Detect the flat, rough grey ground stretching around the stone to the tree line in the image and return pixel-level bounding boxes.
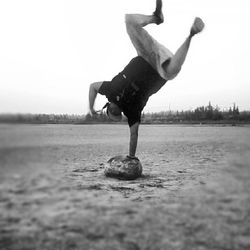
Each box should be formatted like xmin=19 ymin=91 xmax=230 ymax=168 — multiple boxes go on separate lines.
xmin=0 ymin=125 xmax=250 ymax=250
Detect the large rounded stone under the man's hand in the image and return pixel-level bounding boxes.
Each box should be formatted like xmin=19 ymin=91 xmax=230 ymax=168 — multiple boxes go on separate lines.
xmin=104 ymin=155 xmax=142 ymax=180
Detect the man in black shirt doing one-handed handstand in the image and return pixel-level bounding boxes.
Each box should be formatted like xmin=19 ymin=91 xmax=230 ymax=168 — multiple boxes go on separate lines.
xmin=89 ymin=0 xmax=204 ymax=158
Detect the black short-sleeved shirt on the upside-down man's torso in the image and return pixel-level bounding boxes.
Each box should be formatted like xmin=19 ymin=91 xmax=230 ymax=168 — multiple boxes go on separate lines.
xmin=99 ymin=56 xmax=166 ymax=126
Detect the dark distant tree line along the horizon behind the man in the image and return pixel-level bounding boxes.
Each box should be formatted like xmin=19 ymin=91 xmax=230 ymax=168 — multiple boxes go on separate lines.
xmin=0 ymin=102 xmax=250 ymax=124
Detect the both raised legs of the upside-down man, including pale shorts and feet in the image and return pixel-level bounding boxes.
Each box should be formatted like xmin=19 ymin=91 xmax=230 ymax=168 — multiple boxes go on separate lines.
xmin=126 ymin=0 xmax=204 ymax=80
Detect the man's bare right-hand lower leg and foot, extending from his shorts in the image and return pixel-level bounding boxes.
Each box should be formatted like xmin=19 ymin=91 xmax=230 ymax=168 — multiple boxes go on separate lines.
xmin=162 ymin=17 xmax=204 ymax=79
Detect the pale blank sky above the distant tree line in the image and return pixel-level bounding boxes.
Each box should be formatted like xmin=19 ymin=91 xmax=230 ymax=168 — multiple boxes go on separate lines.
xmin=0 ymin=0 xmax=250 ymax=115
